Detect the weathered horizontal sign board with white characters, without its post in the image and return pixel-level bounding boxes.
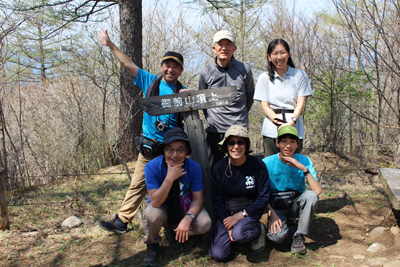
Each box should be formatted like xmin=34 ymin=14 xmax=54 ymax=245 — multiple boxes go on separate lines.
xmin=139 ymin=86 xmax=237 ymax=116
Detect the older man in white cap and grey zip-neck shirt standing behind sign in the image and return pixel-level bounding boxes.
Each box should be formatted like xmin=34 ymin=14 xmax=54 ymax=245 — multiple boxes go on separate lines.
xmin=199 ymin=30 xmax=254 ymax=168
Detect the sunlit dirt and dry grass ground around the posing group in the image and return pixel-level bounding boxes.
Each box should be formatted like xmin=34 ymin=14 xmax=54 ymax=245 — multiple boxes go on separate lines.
xmin=0 ymin=153 xmax=400 ymax=267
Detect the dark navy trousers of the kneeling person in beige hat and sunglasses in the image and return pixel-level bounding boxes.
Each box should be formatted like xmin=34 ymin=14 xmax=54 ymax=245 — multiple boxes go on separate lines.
xmin=208 ymin=216 xmax=261 ymax=261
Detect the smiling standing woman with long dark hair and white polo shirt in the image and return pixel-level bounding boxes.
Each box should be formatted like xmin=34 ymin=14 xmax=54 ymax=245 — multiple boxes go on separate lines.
xmin=254 ymin=39 xmax=313 ymax=157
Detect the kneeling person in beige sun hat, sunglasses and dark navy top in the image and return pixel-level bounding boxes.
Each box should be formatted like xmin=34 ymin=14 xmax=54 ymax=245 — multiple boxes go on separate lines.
xmin=209 ymin=125 xmax=269 ymax=261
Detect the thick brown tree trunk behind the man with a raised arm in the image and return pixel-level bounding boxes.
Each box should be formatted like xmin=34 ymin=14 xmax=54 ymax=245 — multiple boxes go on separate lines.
xmin=118 ymin=0 xmax=143 ymax=162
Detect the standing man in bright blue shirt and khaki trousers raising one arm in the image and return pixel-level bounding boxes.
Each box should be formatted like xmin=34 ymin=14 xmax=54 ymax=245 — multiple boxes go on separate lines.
xmin=98 ymin=29 xmax=185 ymax=234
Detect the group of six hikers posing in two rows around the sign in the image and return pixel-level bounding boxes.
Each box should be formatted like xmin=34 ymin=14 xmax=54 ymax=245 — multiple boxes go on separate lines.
xmin=98 ymin=30 xmax=322 ymax=266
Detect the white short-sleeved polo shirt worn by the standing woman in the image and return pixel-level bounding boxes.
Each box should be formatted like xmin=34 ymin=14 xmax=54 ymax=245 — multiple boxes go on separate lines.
xmin=254 ymin=67 xmax=313 ymax=139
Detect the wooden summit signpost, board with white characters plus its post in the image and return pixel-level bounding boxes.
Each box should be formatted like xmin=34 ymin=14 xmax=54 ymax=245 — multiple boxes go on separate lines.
xmin=139 ymin=86 xmax=237 ymax=222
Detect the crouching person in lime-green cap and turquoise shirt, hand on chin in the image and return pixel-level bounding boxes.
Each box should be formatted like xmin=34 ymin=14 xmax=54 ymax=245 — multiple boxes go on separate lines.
xmin=263 ymin=125 xmax=322 ymax=254
